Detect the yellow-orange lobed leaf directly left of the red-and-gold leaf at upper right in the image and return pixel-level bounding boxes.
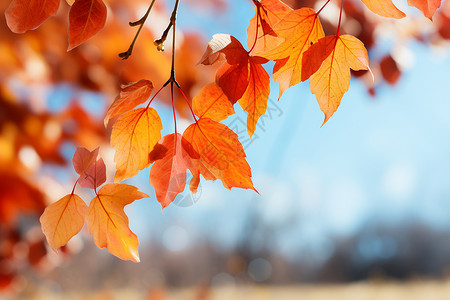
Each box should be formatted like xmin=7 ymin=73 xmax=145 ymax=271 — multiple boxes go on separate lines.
xmin=259 ymin=8 xmax=324 ymax=97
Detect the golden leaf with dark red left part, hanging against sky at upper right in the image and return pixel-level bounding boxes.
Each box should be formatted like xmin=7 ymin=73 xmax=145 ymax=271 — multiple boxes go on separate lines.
xmin=302 ymin=35 xmax=370 ymax=126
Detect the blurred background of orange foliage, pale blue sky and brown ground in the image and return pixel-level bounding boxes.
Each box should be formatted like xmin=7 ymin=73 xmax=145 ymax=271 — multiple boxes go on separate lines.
xmin=0 ymin=0 xmax=450 ymax=299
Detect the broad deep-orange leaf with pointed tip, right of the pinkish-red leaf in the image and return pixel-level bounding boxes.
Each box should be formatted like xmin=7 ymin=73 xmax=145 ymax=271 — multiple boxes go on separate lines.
xmin=183 ymin=118 xmax=256 ymax=191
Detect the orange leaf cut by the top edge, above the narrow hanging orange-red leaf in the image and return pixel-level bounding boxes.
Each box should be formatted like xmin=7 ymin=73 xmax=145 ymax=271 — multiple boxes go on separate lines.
xmin=247 ymin=0 xmax=292 ymax=55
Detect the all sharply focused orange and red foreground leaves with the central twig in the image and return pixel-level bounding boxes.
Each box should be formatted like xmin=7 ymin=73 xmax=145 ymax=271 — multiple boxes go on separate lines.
xmin=5 ymin=0 xmax=446 ymax=261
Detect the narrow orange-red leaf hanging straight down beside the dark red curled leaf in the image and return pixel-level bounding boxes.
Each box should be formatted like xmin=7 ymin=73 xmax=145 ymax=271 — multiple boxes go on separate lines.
xmin=239 ymin=57 xmax=270 ymax=137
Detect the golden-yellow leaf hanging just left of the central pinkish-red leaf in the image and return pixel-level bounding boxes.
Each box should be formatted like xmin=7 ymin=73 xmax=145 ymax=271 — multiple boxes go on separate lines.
xmin=111 ymin=108 xmax=162 ymax=182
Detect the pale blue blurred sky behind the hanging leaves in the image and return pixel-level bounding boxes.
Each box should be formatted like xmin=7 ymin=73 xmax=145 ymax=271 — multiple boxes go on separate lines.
xmin=118 ymin=2 xmax=450 ymax=258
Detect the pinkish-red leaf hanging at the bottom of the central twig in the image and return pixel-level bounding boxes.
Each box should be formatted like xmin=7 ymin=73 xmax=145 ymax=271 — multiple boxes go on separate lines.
xmin=149 ymin=133 xmax=199 ymax=208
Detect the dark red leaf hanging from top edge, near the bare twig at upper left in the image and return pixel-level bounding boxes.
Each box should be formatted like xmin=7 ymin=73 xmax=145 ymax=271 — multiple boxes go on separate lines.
xmin=68 ymin=0 xmax=107 ymax=51
